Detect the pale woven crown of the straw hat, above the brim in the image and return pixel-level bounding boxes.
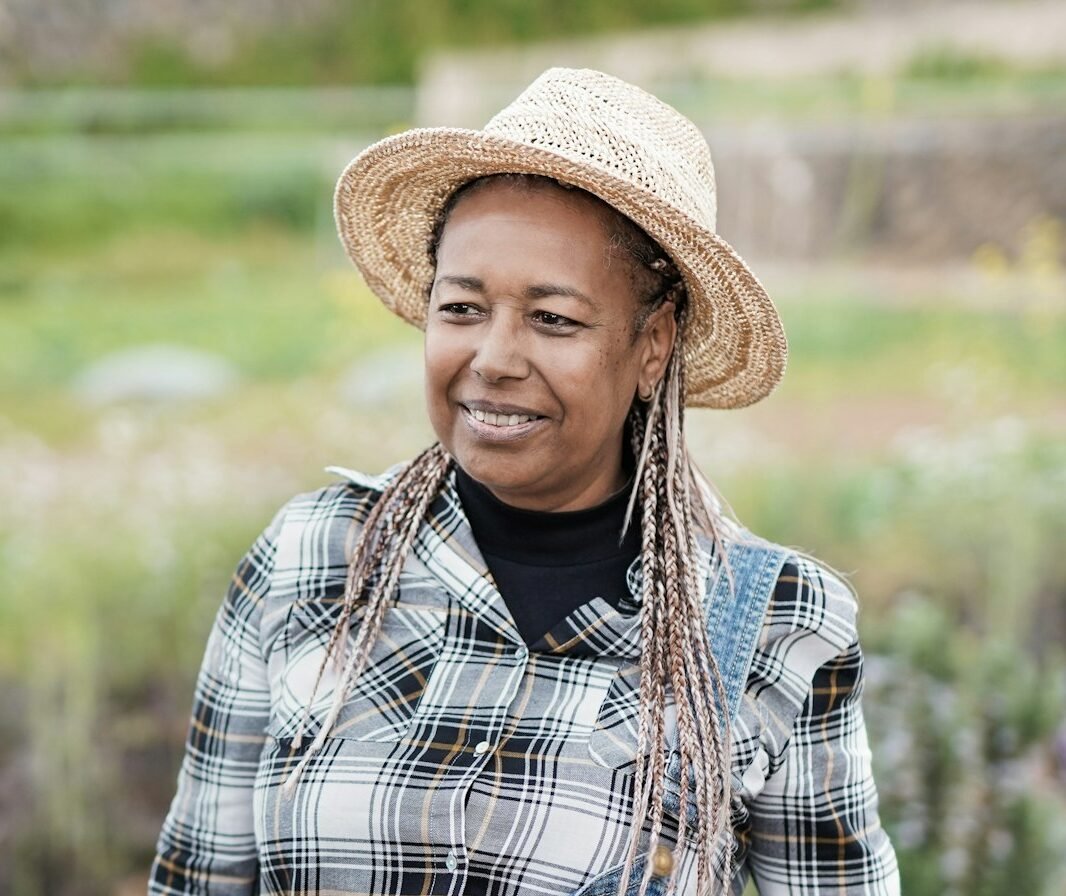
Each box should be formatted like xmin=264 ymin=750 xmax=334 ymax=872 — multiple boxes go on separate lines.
xmin=484 ymin=68 xmax=717 ymax=231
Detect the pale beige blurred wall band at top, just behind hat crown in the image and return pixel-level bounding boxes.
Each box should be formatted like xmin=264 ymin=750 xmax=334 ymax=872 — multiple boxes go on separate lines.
xmin=417 ymin=0 xmax=1066 ymax=127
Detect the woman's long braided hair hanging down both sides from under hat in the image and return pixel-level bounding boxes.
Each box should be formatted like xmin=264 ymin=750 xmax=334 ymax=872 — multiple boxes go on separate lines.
xmin=284 ymin=174 xmax=732 ymax=896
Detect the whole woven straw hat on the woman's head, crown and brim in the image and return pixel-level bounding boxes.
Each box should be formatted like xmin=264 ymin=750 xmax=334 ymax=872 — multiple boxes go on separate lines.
xmin=334 ymin=68 xmax=788 ymax=408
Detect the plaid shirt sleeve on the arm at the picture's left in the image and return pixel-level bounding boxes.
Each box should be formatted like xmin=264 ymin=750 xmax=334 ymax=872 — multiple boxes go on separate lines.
xmin=148 ymin=511 xmax=284 ymax=896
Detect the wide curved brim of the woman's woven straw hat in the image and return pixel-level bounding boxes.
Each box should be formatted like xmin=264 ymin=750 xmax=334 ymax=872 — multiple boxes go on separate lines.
xmin=334 ymin=128 xmax=788 ymax=408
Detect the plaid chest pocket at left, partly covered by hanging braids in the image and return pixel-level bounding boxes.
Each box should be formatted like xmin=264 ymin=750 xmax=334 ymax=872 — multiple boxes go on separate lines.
xmin=269 ymin=580 xmax=448 ymax=743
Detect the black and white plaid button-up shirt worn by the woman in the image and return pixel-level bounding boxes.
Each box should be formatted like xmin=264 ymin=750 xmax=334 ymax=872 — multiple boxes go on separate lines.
xmin=149 ymin=473 xmax=899 ymax=896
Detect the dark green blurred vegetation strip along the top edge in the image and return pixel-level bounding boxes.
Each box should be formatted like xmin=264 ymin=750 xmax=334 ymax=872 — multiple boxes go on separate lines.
xmin=10 ymin=0 xmax=838 ymax=86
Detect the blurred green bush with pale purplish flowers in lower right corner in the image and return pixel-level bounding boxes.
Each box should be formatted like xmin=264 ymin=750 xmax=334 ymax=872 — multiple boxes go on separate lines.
xmin=865 ymin=593 xmax=1066 ymax=896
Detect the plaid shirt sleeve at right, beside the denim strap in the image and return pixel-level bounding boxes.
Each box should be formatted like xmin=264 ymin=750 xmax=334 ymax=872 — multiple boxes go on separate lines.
xmin=747 ymin=567 xmax=900 ymax=896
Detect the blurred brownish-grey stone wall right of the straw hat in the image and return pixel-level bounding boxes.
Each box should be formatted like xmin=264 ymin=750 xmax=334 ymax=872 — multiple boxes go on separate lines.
xmin=708 ymin=114 xmax=1066 ymax=265
